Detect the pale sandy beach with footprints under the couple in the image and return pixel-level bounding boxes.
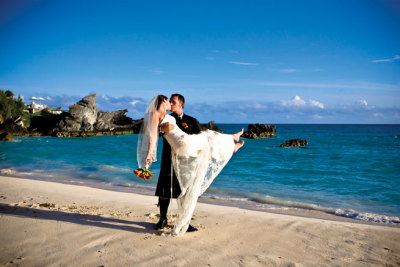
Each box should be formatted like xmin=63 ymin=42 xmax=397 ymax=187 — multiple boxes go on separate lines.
xmin=0 ymin=176 xmax=400 ymax=266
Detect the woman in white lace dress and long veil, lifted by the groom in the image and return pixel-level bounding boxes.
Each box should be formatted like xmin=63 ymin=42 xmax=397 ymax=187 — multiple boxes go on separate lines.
xmin=137 ymin=95 xmax=244 ymax=235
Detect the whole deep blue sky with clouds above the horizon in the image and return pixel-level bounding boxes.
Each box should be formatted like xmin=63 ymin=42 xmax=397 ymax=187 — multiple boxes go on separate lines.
xmin=0 ymin=0 xmax=400 ymax=123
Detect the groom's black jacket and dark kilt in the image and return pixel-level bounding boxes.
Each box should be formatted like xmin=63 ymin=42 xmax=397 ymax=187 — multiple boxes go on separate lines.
xmin=155 ymin=113 xmax=200 ymax=198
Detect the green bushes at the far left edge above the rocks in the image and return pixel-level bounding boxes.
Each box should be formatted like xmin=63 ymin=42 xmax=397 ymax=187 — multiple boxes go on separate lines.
xmin=0 ymin=89 xmax=25 ymax=120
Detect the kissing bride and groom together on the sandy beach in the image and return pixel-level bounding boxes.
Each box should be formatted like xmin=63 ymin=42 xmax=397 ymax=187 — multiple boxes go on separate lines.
xmin=137 ymin=94 xmax=244 ymax=236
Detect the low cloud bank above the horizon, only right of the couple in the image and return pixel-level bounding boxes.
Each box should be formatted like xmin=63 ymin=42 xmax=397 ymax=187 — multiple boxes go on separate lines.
xmin=180 ymin=100 xmax=400 ymax=123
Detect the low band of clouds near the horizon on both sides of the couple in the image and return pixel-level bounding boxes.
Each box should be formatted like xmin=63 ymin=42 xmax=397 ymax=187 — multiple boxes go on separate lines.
xmin=31 ymin=95 xmax=400 ymax=123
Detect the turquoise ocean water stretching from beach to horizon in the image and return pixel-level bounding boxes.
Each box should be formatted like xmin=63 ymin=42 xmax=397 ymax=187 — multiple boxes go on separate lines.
xmin=0 ymin=124 xmax=400 ymax=224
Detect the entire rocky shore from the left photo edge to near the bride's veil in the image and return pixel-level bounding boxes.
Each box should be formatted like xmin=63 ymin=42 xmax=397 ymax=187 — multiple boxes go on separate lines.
xmin=0 ymin=93 xmax=142 ymax=140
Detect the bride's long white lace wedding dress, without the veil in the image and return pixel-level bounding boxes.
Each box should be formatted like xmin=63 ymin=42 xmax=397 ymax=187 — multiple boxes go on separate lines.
xmin=161 ymin=114 xmax=235 ymax=235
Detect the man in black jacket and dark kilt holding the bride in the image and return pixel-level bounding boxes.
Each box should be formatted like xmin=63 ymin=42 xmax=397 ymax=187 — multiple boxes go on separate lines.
xmin=155 ymin=94 xmax=200 ymax=232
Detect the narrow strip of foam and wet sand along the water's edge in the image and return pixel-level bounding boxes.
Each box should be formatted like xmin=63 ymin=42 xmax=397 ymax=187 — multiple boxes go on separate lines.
xmin=0 ymin=172 xmax=400 ymax=227
